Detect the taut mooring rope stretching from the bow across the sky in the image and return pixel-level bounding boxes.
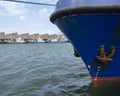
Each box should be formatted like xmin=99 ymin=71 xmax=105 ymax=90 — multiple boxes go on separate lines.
xmin=1 ymin=0 xmax=56 ymax=6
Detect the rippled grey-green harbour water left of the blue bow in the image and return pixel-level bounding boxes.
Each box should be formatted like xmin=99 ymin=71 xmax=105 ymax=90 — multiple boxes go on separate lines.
xmin=0 ymin=43 xmax=90 ymax=96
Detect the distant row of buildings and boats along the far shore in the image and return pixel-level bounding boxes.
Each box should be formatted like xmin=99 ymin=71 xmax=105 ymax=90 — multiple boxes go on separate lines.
xmin=0 ymin=32 xmax=68 ymax=44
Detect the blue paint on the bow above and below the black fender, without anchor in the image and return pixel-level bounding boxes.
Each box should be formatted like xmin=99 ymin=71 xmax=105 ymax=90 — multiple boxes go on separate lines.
xmin=51 ymin=0 xmax=120 ymax=77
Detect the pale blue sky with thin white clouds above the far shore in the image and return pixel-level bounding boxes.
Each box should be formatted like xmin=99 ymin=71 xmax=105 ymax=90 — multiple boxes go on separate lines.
xmin=0 ymin=0 xmax=60 ymax=34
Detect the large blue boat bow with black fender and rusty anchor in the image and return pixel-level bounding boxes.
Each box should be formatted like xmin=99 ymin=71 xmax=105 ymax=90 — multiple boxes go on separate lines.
xmin=50 ymin=0 xmax=120 ymax=82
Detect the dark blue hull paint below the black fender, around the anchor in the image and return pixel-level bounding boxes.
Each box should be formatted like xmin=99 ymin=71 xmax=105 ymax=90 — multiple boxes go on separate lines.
xmin=55 ymin=15 xmax=120 ymax=77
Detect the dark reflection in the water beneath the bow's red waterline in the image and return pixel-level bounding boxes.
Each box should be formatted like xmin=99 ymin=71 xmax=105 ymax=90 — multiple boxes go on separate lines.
xmin=75 ymin=82 xmax=120 ymax=96
